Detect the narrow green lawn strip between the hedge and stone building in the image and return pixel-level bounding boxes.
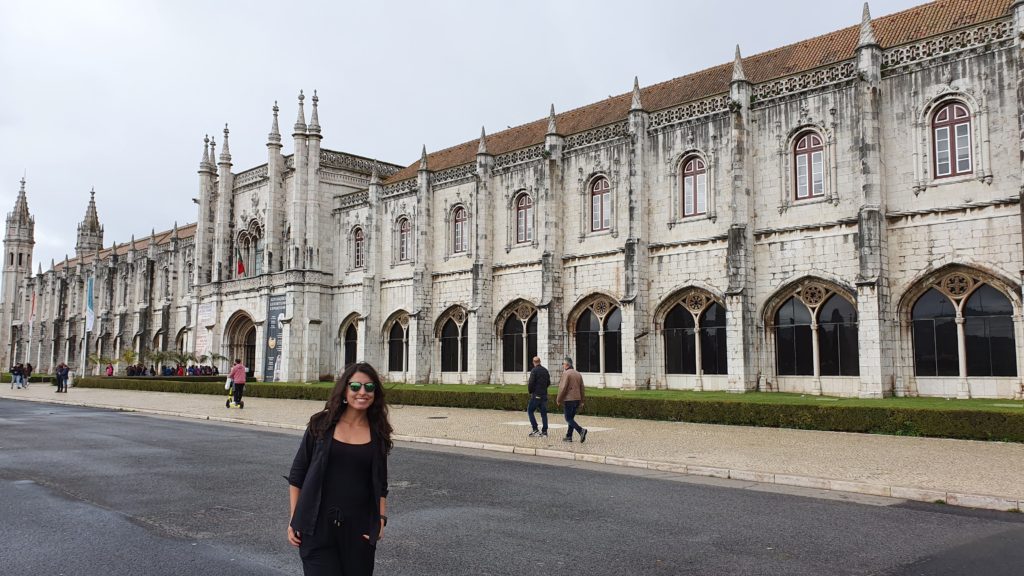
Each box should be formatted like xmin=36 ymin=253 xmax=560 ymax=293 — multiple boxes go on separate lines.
xmin=272 ymin=382 xmax=1024 ymax=413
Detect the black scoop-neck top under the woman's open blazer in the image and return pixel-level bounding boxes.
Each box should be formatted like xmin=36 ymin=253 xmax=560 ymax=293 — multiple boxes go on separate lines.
xmin=321 ymin=439 xmax=375 ymax=530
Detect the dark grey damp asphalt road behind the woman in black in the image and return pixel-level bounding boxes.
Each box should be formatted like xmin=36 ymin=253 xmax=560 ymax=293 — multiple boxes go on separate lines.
xmin=0 ymin=400 xmax=1024 ymax=576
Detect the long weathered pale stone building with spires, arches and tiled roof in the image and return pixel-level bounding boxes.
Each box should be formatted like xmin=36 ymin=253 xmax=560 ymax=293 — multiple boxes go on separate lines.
xmin=0 ymin=0 xmax=1024 ymax=398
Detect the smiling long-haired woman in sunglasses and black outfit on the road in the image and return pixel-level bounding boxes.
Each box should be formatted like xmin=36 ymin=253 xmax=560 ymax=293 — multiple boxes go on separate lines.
xmin=288 ymin=362 xmax=392 ymax=576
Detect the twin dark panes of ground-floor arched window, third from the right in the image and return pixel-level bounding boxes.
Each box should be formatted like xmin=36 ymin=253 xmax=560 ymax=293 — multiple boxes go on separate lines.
xmin=664 ymin=301 xmax=728 ymax=374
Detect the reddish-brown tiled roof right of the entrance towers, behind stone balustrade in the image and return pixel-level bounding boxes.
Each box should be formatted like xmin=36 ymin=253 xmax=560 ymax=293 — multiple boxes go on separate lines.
xmin=387 ymin=0 xmax=1013 ymax=182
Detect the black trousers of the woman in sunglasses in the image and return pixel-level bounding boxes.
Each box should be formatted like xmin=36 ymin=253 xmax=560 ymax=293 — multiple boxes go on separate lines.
xmin=299 ymin=513 xmax=377 ymax=576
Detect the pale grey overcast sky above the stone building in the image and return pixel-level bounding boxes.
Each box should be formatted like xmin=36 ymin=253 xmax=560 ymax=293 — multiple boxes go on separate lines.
xmin=0 ymin=0 xmax=922 ymax=270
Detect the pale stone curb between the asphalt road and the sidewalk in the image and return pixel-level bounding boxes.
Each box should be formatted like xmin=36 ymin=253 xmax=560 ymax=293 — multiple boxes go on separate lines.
xmin=0 ymin=397 xmax=1024 ymax=512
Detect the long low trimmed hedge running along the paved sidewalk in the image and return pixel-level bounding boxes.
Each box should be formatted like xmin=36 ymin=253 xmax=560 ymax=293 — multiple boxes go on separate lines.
xmin=76 ymin=378 xmax=1024 ymax=442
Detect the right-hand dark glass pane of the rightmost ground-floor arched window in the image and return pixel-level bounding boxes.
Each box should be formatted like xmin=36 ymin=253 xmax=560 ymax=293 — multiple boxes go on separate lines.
xmin=964 ymin=284 xmax=1017 ymax=376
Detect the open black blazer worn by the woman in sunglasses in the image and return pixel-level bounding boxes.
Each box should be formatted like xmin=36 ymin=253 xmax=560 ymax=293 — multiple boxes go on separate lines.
xmin=288 ymin=426 xmax=387 ymax=544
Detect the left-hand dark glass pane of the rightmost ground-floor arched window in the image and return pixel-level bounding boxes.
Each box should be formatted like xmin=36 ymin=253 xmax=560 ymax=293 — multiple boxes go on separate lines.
xmin=910 ymin=288 xmax=959 ymax=376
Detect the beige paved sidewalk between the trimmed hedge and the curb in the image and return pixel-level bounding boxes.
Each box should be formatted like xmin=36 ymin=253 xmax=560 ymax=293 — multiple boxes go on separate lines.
xmin=0 ymin=384 xmax=1024 ymax=510
